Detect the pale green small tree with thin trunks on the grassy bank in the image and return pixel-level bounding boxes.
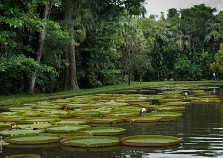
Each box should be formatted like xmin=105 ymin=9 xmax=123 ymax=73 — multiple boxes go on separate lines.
xmin=120 ymin=18 xmax=150 ymax=85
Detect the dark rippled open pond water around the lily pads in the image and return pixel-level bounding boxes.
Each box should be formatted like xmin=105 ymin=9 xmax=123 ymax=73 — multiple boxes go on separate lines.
xmin=0 ymin=84 xmax=223 ymax=158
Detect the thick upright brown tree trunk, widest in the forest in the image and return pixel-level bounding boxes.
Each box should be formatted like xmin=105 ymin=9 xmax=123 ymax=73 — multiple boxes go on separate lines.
xmin=64 ymin=8 xmax=79 ymax=90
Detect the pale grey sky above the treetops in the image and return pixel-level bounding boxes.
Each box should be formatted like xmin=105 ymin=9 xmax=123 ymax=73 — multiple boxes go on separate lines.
xmin=145 ymin=0 xmax=223 ymax=16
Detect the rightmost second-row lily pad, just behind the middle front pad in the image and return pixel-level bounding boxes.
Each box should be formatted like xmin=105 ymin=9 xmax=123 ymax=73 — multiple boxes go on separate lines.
xmin=78 ymin=127 xmax=125 ymax=136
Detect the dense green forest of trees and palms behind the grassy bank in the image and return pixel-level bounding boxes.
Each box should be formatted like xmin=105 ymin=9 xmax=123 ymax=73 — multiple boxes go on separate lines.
xmin=0 ymin=0 xmax=223 ymax=94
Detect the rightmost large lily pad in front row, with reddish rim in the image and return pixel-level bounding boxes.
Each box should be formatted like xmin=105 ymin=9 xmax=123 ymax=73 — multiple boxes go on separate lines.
xmin=122 ymin=135 xmax=180 ymax=146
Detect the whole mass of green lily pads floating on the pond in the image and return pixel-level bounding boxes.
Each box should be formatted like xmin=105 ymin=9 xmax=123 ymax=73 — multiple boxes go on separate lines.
xmin=0 ymin=85 xmax=220 ymax=157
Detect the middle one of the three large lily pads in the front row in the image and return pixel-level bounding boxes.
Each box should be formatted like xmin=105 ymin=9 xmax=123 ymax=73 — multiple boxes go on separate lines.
xmin=61 ymin=136 xmax=120 ymax=147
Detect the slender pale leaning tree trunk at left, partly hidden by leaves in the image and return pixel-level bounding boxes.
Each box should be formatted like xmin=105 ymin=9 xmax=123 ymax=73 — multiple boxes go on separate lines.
xmin=29 ymin=2 xmax=52 ymax=93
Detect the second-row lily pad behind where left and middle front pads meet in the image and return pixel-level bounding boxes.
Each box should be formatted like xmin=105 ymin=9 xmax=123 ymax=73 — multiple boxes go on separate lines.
xmin=46 ymin=125 xmax=90 ymax=133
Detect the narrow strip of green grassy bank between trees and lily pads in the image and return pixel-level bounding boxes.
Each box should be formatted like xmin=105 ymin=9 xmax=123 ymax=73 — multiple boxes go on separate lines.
xmin=0 ymin=81 xmax=223 ymax=106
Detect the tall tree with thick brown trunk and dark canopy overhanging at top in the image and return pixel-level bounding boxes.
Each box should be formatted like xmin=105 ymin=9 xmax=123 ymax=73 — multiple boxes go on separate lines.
xmin=59 ymin=0 xmax=145 ymax=89
